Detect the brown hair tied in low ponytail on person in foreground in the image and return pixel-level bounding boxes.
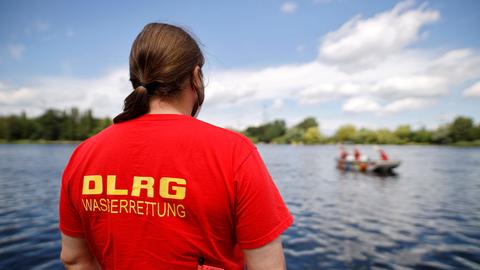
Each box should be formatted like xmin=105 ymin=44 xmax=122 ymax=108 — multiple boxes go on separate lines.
xmin=113 ymin=23 xmax=205 ymax=124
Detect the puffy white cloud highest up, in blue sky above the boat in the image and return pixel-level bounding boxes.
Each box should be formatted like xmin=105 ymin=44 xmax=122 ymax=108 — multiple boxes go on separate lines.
xmin=320 ymin=1 xmax=440 ymax=66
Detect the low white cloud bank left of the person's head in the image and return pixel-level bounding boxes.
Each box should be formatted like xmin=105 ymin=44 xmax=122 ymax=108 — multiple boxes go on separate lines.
xmin=0 ymin=68 xmax=132 ymax=116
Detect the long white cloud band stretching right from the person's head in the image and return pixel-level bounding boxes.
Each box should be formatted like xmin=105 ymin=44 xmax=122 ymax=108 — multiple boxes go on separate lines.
xmin=208 ymin=45 xmax=474 ymax=106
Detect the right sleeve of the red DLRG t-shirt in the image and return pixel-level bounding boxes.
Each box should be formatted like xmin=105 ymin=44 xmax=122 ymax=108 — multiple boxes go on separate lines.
xmin=234 ymin=148 xmax=293 ymax=249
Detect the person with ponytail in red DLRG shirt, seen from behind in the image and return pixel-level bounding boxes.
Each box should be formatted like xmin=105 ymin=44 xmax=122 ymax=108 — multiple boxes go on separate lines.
xmin=59 ymin=23 xmax=293 ymax=270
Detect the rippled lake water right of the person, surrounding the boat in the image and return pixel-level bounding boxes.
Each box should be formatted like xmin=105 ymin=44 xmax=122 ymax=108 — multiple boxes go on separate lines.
xmin=259 ymin=146 xmax=480 ymax=269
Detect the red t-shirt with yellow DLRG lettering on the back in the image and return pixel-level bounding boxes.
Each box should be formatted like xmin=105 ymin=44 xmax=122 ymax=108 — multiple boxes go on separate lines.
xmin=59 ymin=114 xmax=293 ymax=269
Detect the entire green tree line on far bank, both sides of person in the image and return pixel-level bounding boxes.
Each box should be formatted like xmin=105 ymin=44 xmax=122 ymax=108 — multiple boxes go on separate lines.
xmin=0 ymin=107 xmax=480 ymax=146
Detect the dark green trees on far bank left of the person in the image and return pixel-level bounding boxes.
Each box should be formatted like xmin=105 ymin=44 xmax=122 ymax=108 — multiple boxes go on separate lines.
xmin=0 ymin=107 xmax=112 ymax=142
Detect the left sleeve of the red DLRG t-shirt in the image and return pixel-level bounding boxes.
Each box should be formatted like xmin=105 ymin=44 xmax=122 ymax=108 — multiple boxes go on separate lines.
xmin=59 ymin=149 xmax=84 ymax=238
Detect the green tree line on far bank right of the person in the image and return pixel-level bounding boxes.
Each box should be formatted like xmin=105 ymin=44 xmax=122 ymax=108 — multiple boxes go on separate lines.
xmin=241 ymin=116 xmax=480 ymax=146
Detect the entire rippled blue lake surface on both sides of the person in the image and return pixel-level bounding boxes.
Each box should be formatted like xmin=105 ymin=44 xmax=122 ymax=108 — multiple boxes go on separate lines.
xmin=0 ymin=145 xmax=480 ymax=269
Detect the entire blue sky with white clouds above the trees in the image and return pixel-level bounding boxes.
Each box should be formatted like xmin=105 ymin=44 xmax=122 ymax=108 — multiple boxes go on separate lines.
xmin=0 ymin=0 xmax=480 ymax=133
